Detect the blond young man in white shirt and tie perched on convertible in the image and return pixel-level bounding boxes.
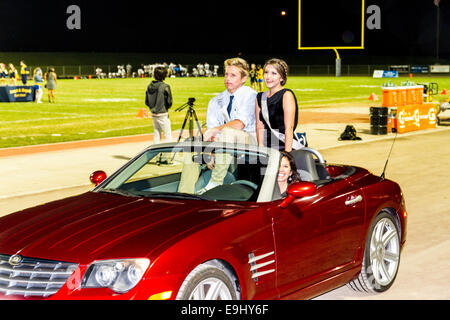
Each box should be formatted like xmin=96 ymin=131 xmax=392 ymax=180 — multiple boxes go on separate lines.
xmin=179 ymin=58 xmax=256 ymax=194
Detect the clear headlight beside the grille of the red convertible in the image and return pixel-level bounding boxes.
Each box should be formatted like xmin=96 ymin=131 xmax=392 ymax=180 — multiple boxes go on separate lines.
xmin=81 ymin=259 xmax=150 ymax=293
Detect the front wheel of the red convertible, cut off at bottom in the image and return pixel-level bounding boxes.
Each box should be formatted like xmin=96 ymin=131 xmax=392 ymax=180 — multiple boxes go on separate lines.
xmin=176 ymin=260 xmax=240 ymax=300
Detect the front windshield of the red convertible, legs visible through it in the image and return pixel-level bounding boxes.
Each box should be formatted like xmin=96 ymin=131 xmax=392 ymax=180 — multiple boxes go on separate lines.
xmin=96 ymin=147 xmax=268 ymax=201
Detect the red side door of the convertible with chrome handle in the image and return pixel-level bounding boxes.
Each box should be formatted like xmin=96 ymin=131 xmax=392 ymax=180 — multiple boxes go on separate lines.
xmin=271 ymin=180 xmax=364 ymax=296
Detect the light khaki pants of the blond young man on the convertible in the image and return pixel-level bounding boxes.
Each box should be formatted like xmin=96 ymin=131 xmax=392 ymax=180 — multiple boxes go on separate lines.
xmin=178 ymin=127 xmax=253 ymax=193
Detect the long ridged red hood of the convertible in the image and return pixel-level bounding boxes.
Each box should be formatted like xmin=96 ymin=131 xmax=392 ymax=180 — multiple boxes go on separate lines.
xmin=0 ymin=192 xmax=244 ymax=264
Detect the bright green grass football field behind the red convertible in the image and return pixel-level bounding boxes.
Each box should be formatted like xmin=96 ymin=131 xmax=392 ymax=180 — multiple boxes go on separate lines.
xmin=0 ymin=77 xmax=450 ymax=148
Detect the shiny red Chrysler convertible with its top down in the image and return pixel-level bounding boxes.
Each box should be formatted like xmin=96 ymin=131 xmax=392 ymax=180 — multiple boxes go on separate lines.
xmin=0 ymin=142 xmax=406 ymax=300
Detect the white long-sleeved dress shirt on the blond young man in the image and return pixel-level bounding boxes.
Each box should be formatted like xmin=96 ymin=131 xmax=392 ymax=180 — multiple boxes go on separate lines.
xmin=206 ymin=86 xmax=256 ymax=133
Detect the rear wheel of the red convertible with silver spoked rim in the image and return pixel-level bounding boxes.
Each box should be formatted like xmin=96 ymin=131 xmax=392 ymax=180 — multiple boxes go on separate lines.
xmin=348 ymin=211 xmax=400 ymax=293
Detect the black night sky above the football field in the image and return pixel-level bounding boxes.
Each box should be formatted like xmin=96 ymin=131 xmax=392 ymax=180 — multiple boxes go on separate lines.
xmin=0 ymin=0 xmax=450 ymax=59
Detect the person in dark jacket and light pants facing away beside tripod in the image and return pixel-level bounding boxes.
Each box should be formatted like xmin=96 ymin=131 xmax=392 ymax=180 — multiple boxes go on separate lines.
xmin=145 ymin=67 xmax=172 ymax=143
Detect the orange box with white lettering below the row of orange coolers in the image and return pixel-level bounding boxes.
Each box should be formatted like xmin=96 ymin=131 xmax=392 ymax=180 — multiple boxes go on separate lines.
xmin=396 ymin=103 xmax=437 ymax=133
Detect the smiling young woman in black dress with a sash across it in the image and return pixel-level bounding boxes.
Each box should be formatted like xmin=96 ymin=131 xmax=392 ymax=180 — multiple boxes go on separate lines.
xmin=255 ymin=59 xmax=298 ymax=152
